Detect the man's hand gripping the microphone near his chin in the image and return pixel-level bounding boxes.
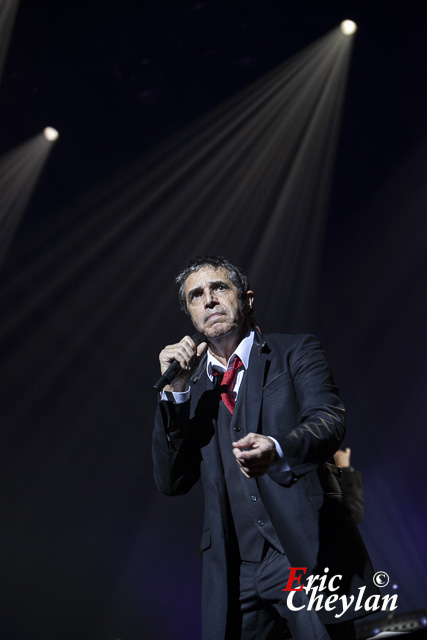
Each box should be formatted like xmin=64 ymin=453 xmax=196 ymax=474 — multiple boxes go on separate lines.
xmin=159 ymin=336 xmax=208 ymax=392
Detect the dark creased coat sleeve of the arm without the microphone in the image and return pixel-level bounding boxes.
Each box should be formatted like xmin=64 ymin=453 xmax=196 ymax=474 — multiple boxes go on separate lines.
xmin=279 ymin=335 xmax=345 ymax=477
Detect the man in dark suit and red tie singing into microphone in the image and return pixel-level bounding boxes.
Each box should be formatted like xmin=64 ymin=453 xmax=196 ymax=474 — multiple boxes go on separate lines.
xmin=153 ymin=256 xmax=376 ymax=640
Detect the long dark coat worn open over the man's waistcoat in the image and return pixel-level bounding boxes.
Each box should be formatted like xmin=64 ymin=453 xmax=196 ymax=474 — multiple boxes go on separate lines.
xmin=153 ymin=333 xmax=376 ymax=640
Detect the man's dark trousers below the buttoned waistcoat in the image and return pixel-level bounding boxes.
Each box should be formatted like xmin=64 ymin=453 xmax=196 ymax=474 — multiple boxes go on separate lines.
xmin=237 ymin=545 xmax=356 ymax=640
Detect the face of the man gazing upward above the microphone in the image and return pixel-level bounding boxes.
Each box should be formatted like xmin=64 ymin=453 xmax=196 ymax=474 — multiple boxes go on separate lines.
xmin=185 ymin=267 xmax=253 ymax=339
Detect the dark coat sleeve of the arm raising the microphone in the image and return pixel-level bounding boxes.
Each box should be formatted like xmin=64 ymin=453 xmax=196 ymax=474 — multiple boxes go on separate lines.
xmin=152 ymin=400 xmax=201 ymax=496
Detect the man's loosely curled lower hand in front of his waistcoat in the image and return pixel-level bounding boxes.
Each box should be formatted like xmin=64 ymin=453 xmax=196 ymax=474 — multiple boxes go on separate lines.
xmin=232 ymin=433 xmax=277 ymax=478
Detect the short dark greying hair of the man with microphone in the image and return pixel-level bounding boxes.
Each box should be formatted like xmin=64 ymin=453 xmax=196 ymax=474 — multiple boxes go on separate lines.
xmin=175 ymin=256 xmax=253 ymax=321
